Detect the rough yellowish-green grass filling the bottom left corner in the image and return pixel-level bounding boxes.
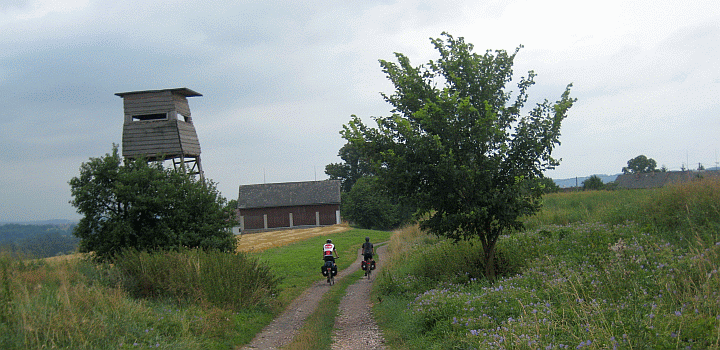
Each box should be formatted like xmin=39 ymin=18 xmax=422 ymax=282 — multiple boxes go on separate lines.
xmin=0 ymin=254 xmax=248 ymax=349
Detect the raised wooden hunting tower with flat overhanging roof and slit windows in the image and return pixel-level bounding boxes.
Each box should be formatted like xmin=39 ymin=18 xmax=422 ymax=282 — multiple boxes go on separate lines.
xmin=115 ymin=88 xmax=203 ymax=178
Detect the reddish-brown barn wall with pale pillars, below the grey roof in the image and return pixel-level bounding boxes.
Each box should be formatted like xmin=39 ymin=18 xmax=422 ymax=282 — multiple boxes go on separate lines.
xmin=238 ymin=204 xmax=340 ymax=230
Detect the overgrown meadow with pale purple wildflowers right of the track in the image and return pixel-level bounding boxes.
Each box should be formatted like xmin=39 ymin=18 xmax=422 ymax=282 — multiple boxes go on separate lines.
xmin=374 ymin=180 xmax=720 ymax=349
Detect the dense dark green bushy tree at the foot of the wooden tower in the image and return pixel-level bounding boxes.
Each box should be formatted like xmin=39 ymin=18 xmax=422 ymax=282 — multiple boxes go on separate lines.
xmin=69 ymin=146 xmax=237 ymax=259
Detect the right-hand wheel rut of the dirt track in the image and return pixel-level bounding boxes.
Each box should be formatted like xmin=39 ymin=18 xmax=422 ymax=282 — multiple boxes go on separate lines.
xmin=332 ymin=246 xmax=385 ymax=350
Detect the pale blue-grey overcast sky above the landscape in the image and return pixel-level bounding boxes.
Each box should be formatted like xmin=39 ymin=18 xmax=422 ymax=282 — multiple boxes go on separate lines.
xmin=0 ymin=0 xmax=720 ymax=221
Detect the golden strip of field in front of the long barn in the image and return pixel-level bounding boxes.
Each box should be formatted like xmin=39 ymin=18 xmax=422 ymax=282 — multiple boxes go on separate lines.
xmin=236 ymin=224 xmax=350 ymax=252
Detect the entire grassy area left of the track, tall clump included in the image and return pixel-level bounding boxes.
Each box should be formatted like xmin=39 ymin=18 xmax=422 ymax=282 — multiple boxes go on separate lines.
xmin=0 ymin=228 xmax=390 ymax=349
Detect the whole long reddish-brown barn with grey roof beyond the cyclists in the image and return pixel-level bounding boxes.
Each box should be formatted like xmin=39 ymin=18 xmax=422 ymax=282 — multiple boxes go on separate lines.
xmin=233 ymin=180 xmax=340 ymax=231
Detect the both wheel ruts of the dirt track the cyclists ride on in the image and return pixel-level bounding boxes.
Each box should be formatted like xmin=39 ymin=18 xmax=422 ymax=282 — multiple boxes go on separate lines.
xmin=241 ymin=243 xmax=384 ymax=350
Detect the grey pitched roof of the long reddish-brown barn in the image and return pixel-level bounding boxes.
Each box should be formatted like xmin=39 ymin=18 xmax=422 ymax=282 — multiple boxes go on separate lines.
xmin=238 ymin=180 xmax=340 ymax=209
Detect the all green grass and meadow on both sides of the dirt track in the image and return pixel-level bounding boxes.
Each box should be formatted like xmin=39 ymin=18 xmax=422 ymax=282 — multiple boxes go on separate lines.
xmin=5 ymin=180 xmax=720 ymax=349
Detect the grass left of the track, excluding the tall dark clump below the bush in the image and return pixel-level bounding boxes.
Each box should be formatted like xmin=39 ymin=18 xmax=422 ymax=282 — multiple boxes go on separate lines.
xmin=0 ymin=230 xmax=390 ymax=349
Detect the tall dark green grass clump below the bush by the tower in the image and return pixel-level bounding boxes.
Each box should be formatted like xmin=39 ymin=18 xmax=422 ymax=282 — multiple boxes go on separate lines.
xmin=108 ymin=249 xmax=279 ymax=310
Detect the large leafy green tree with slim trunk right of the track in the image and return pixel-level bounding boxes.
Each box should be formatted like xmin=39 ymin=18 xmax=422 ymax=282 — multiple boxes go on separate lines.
xmin=342 ymin=33 xmax=575 ymax=280
